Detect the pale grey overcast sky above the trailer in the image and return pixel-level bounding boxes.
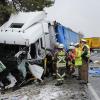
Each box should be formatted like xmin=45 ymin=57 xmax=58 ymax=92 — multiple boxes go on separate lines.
xmin=47 ymin=0 xmax=100 ymax=37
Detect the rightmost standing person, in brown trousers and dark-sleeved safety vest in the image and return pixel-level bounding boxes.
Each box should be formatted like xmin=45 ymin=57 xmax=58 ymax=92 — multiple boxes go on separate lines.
xmin=80 ymin=39 xmax=90 ymax=84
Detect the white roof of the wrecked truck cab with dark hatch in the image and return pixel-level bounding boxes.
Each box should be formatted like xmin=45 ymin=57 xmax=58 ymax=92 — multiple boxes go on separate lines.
xmin=0 ymin=11 xmax=48 ymax=45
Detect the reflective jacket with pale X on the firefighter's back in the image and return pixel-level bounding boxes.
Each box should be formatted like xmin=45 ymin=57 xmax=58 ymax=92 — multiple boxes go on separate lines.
xmin=57 ymin=50 xmax=66 ymax=67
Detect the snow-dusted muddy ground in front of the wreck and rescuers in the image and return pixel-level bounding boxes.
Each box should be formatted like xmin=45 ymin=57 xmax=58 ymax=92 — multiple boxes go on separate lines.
xmin=0 ymin=78 xmax=90 ymax=100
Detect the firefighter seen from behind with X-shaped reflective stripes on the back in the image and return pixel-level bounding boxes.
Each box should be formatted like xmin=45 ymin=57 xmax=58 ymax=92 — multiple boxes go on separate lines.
xmin=54 ymin=44 xmax=66 ymax=86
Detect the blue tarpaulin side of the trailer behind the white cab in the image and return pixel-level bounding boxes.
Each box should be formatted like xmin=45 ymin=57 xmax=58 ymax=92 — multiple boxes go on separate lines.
xmin=56 ymin=24 xmax=80 ymax=49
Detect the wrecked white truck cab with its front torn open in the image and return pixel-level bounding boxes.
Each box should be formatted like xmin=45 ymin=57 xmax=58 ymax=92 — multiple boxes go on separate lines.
xmin=0 ymin=11 xmax=50 ymax=85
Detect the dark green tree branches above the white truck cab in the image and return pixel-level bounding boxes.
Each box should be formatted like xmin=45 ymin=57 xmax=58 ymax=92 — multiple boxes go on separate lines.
xmin=0 ymin=0 xmax=54 ymax=25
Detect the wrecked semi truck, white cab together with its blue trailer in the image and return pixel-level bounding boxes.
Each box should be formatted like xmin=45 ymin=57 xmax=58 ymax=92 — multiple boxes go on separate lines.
xmin=0 ymin=11 xmax=83 ymax=76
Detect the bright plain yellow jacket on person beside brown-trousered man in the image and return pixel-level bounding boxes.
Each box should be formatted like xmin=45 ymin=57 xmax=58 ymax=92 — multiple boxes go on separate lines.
xmin=75 ymin=47 xmax=82 ymax=67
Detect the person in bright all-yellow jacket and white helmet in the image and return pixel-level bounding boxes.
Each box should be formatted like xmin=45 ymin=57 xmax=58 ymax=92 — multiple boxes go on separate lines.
xmin=75 ymin=43 xmax=82 ymax=80
